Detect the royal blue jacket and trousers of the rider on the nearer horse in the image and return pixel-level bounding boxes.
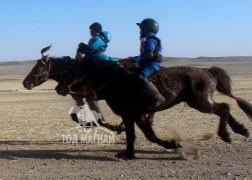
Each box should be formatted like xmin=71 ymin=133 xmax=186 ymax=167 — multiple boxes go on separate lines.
xmin=130 ymin=33 xmax=162 ymax=78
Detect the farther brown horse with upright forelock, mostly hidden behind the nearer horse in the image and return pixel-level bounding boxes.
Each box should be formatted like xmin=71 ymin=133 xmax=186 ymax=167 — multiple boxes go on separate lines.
xmin=23 ymin=47 xmax=125 ymax=133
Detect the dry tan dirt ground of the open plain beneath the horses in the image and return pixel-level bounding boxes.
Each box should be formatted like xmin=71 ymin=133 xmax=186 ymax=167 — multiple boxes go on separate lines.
xmin=0 ymin=59 xmax=252 ymax=180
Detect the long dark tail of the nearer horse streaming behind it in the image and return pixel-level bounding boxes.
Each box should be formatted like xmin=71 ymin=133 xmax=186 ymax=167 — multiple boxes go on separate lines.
xmin=208 ymin=67 xmax=252 ymax=121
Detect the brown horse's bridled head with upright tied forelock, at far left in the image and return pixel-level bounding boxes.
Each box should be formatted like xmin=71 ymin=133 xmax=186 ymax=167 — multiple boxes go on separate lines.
xmin=23 ymin=46 xmax=73 ymax=90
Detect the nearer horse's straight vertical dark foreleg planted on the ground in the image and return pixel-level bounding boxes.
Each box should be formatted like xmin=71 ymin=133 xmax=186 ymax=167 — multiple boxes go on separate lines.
xmin=117 ymin=116 xmax=136 ymax=159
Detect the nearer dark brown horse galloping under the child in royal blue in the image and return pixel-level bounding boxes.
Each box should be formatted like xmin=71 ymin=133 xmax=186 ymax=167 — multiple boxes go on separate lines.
xmin=24 ymin=46 xmax=252 ymax=159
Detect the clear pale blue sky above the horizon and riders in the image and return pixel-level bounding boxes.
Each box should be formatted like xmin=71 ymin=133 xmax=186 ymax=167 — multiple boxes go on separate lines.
xmin=0 ymin=0 xmax=252 ymax=61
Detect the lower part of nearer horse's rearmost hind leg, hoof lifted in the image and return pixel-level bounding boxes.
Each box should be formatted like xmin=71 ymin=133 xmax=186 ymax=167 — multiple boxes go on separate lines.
xmin=228 ymin=114 xmax=249 ymax=138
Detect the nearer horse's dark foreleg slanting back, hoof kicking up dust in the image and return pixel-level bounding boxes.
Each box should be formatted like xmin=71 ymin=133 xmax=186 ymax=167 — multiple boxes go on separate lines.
xmin=136 ymin=115 xmax=182 ymax=149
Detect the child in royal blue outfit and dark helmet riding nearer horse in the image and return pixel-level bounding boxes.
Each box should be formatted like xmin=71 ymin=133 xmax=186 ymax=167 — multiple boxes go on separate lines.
xmin=129 ymin=18 xmax=165 ymax=109
